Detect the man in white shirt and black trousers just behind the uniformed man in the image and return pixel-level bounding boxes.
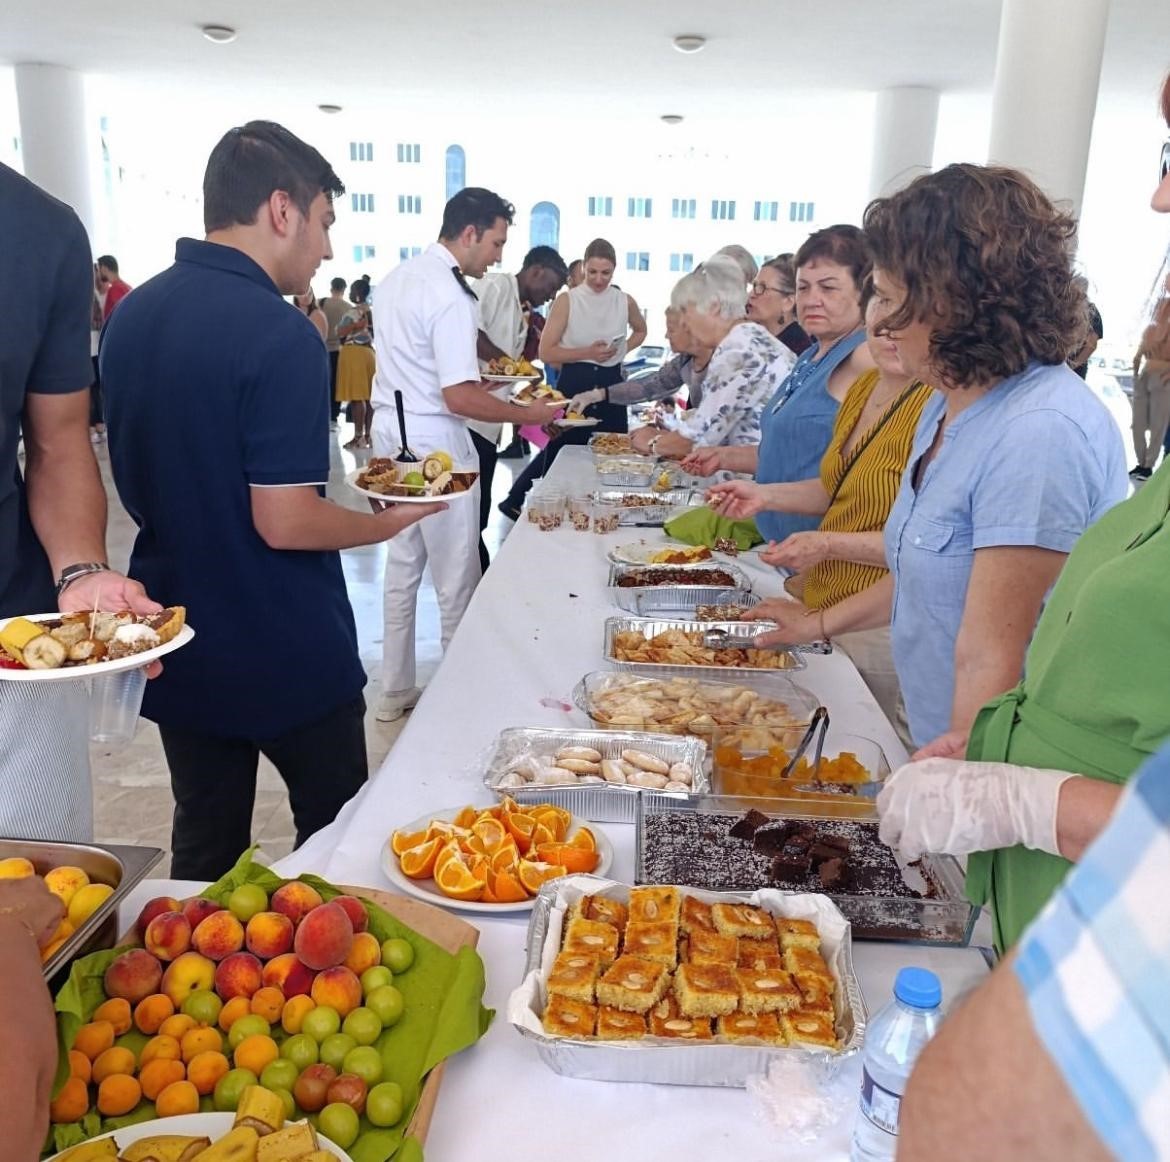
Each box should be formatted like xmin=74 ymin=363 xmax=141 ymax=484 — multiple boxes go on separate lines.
xmin=468 ymin=246 xmax=569 ymax=571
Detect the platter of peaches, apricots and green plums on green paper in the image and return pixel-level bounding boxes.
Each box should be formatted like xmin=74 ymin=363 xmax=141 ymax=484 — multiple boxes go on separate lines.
xmin=50 ymin=855 xmax=491 ymax=1162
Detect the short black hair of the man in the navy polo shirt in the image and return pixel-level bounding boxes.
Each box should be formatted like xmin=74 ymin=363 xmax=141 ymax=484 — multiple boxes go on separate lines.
xmin=204 ymin=121 xmax=345 ymax=234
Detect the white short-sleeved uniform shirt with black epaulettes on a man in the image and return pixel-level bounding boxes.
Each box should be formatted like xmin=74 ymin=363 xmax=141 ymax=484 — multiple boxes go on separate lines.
xmin=373 ymin=242 xmax=480 ymax=424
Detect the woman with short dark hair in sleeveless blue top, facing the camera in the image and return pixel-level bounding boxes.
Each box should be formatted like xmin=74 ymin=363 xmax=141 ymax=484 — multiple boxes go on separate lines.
xmin=682 ymin=226 xmax=874 ymax=541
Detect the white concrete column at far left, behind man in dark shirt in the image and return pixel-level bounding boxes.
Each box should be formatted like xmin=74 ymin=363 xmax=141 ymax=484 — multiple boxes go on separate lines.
xmin=16 ymin=64 xmax=94 ymax=238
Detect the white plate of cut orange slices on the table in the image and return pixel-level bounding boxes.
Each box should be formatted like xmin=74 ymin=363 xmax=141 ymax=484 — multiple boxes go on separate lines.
xmin=381 ymin=797 xmax=613 ymax=912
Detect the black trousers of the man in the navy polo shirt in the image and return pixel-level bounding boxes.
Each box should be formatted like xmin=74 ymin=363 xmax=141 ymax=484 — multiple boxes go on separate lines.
xmin=159 ymin=695 xmax=370 ymax=880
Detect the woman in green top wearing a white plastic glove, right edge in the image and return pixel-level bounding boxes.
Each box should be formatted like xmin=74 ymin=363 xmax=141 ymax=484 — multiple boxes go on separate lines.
xmin=878 ymin=70 xmax=1170 ymax=951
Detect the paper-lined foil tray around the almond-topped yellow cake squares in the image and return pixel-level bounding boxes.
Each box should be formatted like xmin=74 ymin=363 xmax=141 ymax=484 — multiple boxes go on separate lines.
xmin=507 ymin=875 xmax=867 ymax=1087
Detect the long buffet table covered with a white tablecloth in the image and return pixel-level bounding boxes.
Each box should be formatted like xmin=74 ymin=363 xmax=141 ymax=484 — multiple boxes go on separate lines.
xmin=125 ymin=447 xmax=987 ymax=1162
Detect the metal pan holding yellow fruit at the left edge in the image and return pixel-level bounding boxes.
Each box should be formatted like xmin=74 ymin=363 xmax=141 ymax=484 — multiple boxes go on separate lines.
xmin=0 ymin=839 xmax=163 ymax=981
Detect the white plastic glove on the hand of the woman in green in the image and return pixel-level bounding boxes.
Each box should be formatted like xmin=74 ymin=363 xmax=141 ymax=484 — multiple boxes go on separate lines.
xmin=878 ymin=758 xmax=1075 ymax=860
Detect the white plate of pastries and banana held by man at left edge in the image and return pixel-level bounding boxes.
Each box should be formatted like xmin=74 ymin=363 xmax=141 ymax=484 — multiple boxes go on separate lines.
xmin=0 ymin=605 xmax=195 ymax=682
